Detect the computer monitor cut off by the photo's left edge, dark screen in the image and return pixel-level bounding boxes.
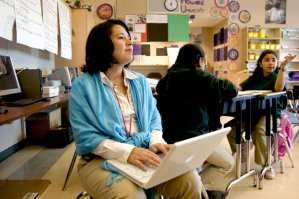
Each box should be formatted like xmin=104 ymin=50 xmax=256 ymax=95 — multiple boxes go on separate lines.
xmin=0 ymin=55 xmax=21 ymax=97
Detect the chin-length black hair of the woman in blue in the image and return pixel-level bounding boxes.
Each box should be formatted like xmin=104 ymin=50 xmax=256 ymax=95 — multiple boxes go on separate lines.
xmin=82 ymin=19 xmax=130 ymax=74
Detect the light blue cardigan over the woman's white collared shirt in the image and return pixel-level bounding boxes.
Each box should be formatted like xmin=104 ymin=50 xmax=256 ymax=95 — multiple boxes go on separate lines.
xmin=69 ymin=69 xmax=162 ymax=155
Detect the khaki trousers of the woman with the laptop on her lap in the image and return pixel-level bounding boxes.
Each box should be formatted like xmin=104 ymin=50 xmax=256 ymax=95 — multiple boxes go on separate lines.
xmin=78 ymin=157 xmax=202 ymax=199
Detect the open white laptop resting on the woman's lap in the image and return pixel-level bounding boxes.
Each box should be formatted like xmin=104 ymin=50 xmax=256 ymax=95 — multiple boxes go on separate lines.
xmin=107 ymin=127 xmax=231 ymax=189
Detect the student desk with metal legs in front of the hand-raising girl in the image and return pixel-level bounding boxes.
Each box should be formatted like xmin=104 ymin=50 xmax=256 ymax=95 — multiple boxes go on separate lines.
xmin=223 ymin=91 xmax=286 ymax=197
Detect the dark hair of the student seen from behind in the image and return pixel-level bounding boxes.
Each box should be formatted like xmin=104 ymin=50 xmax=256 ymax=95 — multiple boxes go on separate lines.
xmin=175 ymin=44 xmax=205 ymax=68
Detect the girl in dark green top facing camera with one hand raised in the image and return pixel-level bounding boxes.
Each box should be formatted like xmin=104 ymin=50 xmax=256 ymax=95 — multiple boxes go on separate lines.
xmin=227 ymin=50 xmax=295 ymax=179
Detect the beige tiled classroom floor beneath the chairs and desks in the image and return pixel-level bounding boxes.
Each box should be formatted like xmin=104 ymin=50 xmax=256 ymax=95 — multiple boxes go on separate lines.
xmin=0 ymin=128 xmax=299 ymax=199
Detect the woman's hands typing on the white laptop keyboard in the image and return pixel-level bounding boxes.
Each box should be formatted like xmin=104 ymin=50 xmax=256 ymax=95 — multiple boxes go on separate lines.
xmin=127 ymin=147 xmax=160 ymax=171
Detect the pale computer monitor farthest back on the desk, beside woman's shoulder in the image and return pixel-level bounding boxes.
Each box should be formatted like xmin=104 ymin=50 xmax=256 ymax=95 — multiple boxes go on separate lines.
xmin=47 ymin=66 xmax=72 ymax=88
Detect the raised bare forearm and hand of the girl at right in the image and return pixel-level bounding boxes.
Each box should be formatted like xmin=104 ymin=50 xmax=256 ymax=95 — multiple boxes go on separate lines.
xmin=274 ymin=54 xmax=296 ymax=92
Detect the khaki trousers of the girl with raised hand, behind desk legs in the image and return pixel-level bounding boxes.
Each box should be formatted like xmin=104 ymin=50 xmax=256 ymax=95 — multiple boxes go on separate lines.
xmin=227 ymin=116 xmax=281 ymax=166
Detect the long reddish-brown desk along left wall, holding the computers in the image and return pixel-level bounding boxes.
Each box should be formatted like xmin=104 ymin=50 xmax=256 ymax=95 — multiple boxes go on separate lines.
xmin=0 ymin=93 xmax=69 ymax=126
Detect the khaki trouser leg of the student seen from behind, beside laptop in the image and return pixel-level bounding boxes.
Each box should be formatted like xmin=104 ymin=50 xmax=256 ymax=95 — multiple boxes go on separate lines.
xmin=199 ymin=144 xmax=235 ymax=190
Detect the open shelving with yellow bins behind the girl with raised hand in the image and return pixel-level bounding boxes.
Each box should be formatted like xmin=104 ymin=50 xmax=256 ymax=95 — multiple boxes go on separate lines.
xmin=243 ymin=27 xmax=299 ymax=88
